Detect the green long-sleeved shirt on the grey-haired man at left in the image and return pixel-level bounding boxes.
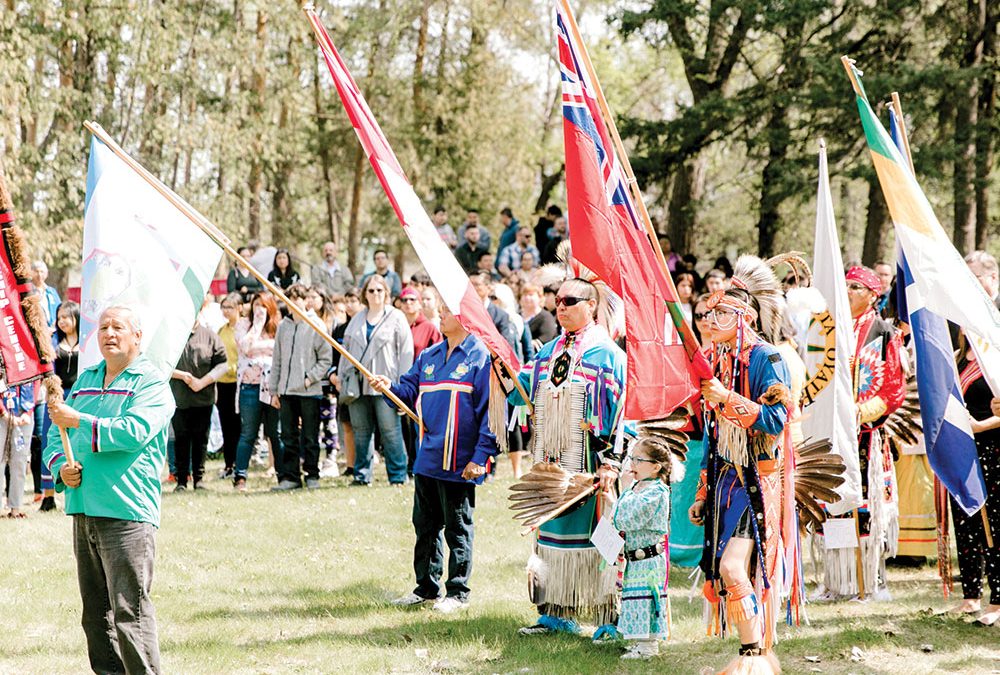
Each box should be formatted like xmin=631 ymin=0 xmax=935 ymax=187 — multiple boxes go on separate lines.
xmin=43 ymin=355 xmax=174 ymax=527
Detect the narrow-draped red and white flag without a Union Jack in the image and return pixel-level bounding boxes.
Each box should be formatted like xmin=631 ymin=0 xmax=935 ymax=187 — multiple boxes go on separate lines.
xmin=305 ymin=8 xmax=521 ymax=373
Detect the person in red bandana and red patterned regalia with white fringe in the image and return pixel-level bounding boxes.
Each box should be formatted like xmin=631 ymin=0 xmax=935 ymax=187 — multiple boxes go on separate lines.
xmin=822 ymin=266 xmax=906 ymax=599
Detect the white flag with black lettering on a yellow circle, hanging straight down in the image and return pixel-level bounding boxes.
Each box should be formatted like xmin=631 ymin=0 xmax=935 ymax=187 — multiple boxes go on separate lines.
xmin=801 ymin=145 xmax=861 ymax=515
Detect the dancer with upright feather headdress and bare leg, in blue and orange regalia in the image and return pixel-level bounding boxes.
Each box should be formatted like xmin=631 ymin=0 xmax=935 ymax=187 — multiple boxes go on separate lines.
xmin=689 ymin=255 xmax=797 ymax=673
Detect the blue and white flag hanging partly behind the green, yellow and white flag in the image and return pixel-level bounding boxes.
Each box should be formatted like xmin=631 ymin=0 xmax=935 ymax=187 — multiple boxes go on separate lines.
xmin=889 ymin=108 xmax=986 ymax=515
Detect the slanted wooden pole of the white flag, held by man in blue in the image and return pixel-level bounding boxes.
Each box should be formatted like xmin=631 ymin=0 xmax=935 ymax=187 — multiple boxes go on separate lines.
xmin=83 ymin=122 xmax=422 ymax=424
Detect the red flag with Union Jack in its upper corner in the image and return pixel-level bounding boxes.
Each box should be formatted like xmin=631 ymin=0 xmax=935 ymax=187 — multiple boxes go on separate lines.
xmin=556 ymin=3 xmax=711 ymax=419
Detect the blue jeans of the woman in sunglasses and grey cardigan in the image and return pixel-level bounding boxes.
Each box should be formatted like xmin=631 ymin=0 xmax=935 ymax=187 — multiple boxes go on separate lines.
xmin=350 ymin=396 xmax=406 ymax=483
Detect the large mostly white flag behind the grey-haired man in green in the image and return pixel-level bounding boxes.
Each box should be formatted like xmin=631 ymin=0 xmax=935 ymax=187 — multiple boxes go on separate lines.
xmin=80 ymin=132 xmax=225 ymax=377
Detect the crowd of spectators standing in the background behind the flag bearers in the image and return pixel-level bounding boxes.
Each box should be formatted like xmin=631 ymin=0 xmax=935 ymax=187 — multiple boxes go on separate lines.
xmin=0 ymin=205 xmax=744 ymax=518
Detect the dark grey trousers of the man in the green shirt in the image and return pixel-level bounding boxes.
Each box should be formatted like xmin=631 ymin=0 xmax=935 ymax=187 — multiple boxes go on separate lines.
xmin=73 ymin=514 xmax=160 ymax=674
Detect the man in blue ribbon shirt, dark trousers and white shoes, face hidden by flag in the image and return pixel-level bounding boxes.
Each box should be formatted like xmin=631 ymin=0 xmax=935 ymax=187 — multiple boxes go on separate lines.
xmin=370 ymin=294 xmax=497 ymax=613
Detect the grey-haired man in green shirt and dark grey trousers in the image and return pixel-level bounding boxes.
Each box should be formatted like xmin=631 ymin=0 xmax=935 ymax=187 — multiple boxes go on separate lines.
xmin=45 ymin=307 xmax=174 ymax=673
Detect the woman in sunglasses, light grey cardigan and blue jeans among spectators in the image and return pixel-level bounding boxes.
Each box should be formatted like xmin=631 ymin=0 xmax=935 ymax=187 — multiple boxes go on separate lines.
xmin=337 ymin=274 xmax=413 ymax=485
